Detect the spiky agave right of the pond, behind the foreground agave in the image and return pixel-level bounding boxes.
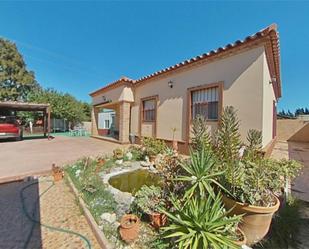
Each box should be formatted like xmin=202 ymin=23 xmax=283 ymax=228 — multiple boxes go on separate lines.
xmin=176 ymin=147 xmax=228 ymax=199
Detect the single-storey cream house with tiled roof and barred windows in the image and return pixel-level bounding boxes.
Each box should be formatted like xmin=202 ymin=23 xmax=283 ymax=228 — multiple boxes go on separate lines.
xmin=90 ymin=24 xmax=281 ymax=154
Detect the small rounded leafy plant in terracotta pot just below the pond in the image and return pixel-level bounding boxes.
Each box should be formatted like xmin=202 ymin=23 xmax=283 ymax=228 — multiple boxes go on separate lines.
xmin=131 ymin=185 xmax=166 ymax=228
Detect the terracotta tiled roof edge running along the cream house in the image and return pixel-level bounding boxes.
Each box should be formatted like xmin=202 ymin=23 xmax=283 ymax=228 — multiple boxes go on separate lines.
xmin=90 ymin=24 xmax=281 ymax=98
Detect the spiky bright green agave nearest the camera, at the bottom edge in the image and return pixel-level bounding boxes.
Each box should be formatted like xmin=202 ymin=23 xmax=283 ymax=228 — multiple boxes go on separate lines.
xmin=162 ymin=195 xmax=241 ymax=249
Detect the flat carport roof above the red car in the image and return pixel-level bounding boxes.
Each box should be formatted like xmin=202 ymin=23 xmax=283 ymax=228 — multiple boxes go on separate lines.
xmin=0 ymin=101 xmax=49 ymax=111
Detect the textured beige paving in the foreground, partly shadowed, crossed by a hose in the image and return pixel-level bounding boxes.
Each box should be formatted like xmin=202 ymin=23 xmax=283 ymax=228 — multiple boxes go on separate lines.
xmin=0 ymin=178 xmax=100 ymax=249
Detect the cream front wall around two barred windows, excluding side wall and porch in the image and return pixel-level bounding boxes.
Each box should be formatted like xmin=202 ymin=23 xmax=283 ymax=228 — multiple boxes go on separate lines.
xmin=131 ymin=47 xmax=264 ymax=143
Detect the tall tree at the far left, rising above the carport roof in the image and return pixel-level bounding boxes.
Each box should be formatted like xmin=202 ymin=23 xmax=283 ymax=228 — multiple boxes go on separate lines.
xmin=0 ymin=38 xmax=38 ymax=101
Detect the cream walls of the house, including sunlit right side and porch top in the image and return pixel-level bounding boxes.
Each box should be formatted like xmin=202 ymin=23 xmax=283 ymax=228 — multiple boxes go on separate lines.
xmin=93 ymin=46 xmax=275 ymax=146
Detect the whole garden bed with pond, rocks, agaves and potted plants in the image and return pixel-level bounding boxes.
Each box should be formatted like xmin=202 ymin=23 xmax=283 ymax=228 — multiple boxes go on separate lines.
xmin=65 ymin=107 xmax=302 ymax=249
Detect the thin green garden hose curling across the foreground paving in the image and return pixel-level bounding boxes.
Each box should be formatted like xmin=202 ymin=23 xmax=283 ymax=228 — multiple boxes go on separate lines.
xmin=20 ymin=180 xmax=91 ymax=249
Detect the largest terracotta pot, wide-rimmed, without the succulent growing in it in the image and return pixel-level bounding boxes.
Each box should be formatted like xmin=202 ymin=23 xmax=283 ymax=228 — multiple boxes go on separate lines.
xmin=222 ymin=196 xmax=280 ymax=245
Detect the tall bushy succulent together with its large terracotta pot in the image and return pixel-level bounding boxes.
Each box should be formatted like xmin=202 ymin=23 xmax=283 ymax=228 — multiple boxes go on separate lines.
xmin=214 ymin=107 xmax=297 ymax=245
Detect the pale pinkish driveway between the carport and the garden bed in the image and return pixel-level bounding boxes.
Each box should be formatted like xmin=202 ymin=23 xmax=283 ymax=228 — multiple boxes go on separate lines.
xmin=0 ymin=136 xmax=121 ymax=183
